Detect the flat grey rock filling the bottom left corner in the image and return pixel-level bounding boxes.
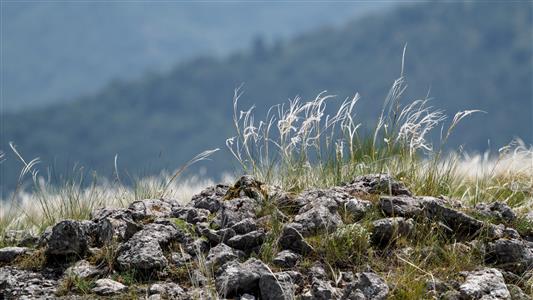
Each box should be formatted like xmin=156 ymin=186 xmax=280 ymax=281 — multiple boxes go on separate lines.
xmin=0 ymin=267 xmax=58 ymax=300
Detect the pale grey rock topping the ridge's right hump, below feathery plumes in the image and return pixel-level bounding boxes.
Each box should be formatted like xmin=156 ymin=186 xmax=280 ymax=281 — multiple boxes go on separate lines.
xmin=344 ymin=174 xmax=411 ymax=196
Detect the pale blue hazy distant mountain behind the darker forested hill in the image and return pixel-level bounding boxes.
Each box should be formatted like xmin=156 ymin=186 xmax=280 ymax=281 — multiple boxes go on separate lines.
xmin=1 ymin=1 xmax=392 ymax=110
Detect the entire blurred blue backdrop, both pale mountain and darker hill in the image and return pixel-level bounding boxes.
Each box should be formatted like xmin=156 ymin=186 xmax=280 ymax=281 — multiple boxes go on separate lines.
xmin=0 ymin=1 xmax=533 ymax=198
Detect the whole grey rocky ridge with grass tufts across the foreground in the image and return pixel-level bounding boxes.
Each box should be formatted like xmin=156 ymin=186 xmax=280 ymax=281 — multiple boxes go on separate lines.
xmin=0 ymin=174 xmax=533 ymax=300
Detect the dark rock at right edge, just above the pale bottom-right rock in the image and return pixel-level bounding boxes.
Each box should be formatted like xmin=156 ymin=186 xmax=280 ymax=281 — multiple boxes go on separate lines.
xmin=485 ymin=239 xmax=533 ymax=274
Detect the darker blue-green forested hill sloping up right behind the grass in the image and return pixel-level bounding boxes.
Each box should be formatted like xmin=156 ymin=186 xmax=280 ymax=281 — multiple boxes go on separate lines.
xmin=2 ymin=1 xmax=533 ymax=195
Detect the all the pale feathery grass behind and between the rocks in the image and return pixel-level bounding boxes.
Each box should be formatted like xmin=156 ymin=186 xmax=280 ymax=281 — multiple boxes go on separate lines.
xmin=0 ymin=58 xmax=533 ymax=299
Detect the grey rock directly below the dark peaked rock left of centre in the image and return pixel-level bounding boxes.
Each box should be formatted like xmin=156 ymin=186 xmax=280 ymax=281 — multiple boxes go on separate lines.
xmin=215 ymin=198 xmax=259 ymax=228
